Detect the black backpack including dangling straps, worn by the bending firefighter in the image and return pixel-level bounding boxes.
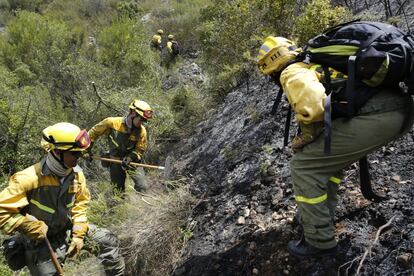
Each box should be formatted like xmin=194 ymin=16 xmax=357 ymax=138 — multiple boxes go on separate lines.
xmin=272 ymin=20 xmax=414 ymax=153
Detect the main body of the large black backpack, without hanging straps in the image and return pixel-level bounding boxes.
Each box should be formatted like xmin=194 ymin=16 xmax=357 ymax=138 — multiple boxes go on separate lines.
xmin=299 ymin=21 xmax=414 ymax=94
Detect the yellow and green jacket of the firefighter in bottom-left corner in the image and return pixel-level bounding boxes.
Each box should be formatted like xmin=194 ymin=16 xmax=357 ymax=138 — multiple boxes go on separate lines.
xmin=0 ymin=158 xmax=90 ymax=236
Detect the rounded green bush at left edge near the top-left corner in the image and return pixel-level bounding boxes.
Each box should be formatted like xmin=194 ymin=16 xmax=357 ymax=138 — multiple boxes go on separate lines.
xmin=0 ymin=11 xmax=71 ymax=85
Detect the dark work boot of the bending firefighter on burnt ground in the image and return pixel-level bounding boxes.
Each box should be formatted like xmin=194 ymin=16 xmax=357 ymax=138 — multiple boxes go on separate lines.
xmin=288 ymin=239 xmax=338 ymax=258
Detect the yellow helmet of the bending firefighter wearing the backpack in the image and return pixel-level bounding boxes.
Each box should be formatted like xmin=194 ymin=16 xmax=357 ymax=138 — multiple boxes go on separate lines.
xmin=257 ymin=36 xmax=301 ymax=75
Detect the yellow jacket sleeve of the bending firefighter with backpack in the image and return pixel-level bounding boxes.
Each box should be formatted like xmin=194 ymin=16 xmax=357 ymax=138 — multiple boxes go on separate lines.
xmin=280 ymin=62 xmax=326 ymax=124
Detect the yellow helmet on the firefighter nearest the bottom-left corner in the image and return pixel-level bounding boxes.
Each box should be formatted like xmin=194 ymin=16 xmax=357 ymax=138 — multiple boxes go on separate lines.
xmin=40 ymin=122 xmax=91 ymax=151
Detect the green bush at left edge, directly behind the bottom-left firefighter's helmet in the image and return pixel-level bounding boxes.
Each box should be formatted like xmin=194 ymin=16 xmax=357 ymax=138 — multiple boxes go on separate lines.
xmin=0 ymin=82 xmax=65 ymax=174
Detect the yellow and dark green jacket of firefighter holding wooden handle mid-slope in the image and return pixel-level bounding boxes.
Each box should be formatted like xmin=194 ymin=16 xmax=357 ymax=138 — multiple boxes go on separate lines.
xmin=88 ymin=117 xmax=148 ymax=159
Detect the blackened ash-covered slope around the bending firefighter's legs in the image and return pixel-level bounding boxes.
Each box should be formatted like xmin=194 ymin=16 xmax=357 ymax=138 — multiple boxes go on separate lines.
xmin=174 ymin=77 xmax=414 ymax=276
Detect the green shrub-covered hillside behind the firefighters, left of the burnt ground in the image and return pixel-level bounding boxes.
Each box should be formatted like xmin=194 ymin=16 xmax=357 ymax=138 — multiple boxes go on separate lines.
xmin=0 ymin=0 xmax=402 ymax=273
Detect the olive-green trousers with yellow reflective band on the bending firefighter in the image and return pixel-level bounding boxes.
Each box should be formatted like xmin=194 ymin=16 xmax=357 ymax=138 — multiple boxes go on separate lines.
xmin=290 ymin=92 xmax=405 ymax=249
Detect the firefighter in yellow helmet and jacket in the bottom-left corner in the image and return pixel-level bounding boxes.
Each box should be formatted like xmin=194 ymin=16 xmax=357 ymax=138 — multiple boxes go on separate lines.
xmin=0 ymin=122 xmax=124 ymax=275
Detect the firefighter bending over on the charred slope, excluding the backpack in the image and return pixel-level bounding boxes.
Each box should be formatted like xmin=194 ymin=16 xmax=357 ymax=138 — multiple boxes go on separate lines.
xmin=258 ymin=36 xmax=414 ymax=258
